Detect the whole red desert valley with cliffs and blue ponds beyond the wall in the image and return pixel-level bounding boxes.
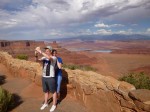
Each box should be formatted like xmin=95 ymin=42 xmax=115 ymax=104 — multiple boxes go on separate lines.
xmin=0 ymin=40 xmax=150 ymax=78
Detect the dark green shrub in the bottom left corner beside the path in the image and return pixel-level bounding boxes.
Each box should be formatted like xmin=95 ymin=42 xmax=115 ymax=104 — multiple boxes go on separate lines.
xmin=0 ymin=87 xmax=15 ymax=112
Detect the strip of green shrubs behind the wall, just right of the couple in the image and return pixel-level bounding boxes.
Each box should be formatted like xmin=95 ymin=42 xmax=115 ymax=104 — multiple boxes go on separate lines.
xmin=63 ymin=64 xmax=96 ymax=71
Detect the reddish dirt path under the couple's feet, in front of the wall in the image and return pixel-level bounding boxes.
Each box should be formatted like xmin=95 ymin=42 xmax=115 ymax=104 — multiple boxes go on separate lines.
xmin=0 ymin=65 xmax=87 ymax=112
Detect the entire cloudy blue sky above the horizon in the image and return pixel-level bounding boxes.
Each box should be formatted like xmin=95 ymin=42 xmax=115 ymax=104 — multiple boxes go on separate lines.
xmin=0 ymin=0 xmax=150 ymax=39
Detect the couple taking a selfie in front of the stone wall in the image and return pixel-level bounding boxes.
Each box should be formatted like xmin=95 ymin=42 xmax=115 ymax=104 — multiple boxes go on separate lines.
xmin=35 ymin=46 xmax=62 ymax=112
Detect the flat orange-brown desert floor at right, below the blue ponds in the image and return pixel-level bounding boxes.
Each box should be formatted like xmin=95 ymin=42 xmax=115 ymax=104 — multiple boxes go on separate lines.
xmin=80 ymin=53 xmax=150 ymax=78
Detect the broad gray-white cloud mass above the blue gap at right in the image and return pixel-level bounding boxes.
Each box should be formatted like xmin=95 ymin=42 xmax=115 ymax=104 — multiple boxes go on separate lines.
xmin=0 ymin=0 xmax=150 ymax=38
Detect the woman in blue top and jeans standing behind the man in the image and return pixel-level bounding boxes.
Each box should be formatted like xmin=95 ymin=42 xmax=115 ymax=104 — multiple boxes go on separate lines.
xmin=52 ymin=49 xmax=63 ymax=100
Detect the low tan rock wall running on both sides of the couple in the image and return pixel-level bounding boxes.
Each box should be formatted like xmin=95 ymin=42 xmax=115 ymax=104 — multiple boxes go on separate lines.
xmin=0 ymin=52 xmax=150 ymax=112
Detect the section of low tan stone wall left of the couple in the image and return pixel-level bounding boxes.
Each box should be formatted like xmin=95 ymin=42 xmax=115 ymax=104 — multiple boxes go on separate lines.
xmin=0 ymin=52 xmax=41 ymax=81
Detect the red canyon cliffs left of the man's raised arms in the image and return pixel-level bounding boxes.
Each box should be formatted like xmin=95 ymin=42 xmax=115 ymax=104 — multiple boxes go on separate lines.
xmin=0 ymin=40 xmax=45 ymax=57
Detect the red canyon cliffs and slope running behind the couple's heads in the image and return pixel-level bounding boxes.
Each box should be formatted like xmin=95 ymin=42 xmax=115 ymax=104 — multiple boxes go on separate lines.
xmin=0 ymin=40 xmax=97 ymax=65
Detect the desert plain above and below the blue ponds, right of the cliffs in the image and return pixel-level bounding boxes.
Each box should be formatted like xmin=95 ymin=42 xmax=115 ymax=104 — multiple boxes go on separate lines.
xmin=60 ymin=40 xmax=150 ymax=79
